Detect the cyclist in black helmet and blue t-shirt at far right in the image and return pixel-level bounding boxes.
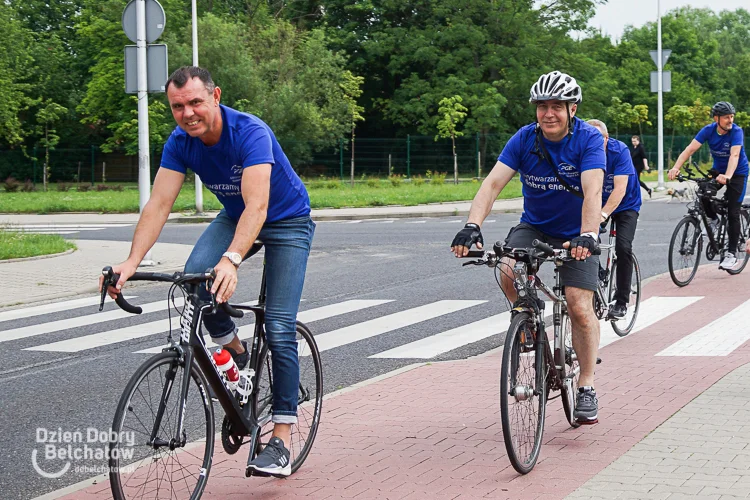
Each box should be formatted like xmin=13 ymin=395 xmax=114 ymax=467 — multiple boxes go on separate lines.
xmin=669 ymin=101 xmax=748 ymax=269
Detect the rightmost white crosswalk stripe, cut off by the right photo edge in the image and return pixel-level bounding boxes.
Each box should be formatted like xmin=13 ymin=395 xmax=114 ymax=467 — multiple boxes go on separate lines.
xmin=656 ymin=300 xmax=750 ymax=356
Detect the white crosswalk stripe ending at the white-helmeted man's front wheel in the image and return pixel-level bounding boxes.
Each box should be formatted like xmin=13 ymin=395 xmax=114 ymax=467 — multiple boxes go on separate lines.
xmin=370 ymin=311 xmax=510 ymax=359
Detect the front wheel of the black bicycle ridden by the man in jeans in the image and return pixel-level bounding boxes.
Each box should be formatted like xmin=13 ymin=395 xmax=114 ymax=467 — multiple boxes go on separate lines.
xmin=109 ymin=351 xmax=214 ymax=500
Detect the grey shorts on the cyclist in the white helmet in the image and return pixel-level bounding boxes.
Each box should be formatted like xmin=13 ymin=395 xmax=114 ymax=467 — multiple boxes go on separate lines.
xmin=505 ymin=222 xmax=599 ymax=291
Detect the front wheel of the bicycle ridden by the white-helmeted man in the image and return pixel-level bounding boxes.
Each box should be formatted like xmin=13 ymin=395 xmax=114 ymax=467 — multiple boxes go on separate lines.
xmin=500 ymin=312 xmax=548 ymax=474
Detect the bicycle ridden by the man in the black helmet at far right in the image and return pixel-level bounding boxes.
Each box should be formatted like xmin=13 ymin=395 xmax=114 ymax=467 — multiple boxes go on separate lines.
xmin=668 ymin=165 xmax=750 ymax=287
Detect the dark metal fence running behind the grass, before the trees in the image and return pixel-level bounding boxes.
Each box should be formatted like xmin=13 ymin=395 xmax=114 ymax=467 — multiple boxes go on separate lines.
xmin=0 ymin=134 xmax=728 ymax=184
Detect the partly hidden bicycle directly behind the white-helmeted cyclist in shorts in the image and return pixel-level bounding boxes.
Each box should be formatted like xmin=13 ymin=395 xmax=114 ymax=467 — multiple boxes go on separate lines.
xmin=594 ymin=220 xmax=641 ymax=337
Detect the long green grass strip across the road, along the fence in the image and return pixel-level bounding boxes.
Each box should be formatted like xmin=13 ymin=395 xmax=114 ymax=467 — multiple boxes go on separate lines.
xmin=0 ymin=178 xmax=521 ymax=214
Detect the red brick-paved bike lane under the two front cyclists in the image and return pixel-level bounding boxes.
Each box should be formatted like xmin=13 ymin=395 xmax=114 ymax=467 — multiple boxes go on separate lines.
xmin=57 ymin=265 xmax=750 ymax=499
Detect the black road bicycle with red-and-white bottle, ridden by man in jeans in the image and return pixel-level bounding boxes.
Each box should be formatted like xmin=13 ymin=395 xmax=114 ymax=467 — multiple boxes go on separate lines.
xmin=100 ymin=242 xmax=323 ymax=500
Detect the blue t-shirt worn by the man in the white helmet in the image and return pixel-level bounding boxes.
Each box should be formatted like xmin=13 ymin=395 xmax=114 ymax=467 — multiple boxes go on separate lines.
xmin=498 ymin=118 xmax=606 ymax=238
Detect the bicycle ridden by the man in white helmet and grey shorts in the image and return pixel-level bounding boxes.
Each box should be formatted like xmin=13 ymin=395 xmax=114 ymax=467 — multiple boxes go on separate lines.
xmin=464 ymin=240 xmax=601 ymax=474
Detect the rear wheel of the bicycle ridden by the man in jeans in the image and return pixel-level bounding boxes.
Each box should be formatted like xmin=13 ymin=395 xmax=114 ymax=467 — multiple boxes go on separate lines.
xmin=254 ymin=322 xmax=323 ymax=472
